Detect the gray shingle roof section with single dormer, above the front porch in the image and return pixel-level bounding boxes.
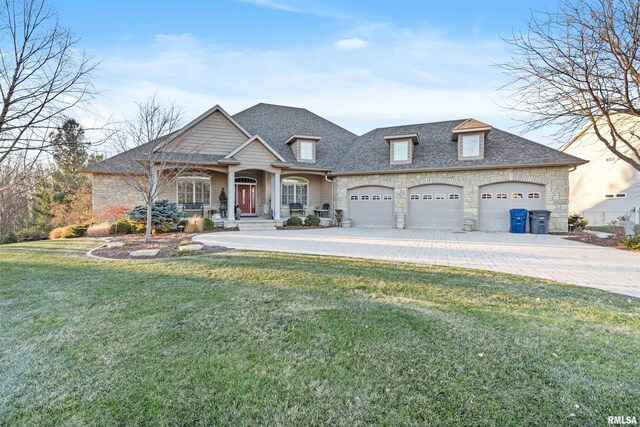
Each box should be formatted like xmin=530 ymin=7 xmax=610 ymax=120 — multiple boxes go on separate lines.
xmin=233 ymin=104 xmax=357 ymax=169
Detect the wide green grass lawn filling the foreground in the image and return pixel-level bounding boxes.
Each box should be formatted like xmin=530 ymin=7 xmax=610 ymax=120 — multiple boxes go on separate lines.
xmin=0 ymin=240 xmax=640 ymax=426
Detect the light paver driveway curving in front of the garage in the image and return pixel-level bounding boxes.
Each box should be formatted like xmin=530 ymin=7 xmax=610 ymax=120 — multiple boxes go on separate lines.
xmin=194 ymin=228 xmax=640 ymax=297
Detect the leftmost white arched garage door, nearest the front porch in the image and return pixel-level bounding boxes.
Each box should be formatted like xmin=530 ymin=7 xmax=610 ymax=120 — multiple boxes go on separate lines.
xmin=347 ymin=187 xmax=395 ymax=227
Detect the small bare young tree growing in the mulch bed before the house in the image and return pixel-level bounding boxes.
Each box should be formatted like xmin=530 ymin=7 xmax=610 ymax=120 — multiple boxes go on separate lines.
xmin=116 ymin=95 xmax=198 ymax=243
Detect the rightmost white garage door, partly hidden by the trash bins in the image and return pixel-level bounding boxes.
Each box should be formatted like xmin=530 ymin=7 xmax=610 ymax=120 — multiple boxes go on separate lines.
xmin=478 ymin=182 xmax=545 ymax=231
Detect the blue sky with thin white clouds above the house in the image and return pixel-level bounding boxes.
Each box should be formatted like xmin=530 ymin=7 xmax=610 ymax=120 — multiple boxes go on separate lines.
xmin=50 ymin=0 xmax=563 ymax=147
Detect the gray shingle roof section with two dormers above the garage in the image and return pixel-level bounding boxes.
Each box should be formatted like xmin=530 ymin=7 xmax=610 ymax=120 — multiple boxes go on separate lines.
xmin=333 ymin=119 xmax=584 ymax=173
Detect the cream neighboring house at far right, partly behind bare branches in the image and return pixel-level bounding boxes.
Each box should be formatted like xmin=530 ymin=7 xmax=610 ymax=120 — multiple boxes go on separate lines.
xmin=560 ymin=114 xmax=640 ymax=225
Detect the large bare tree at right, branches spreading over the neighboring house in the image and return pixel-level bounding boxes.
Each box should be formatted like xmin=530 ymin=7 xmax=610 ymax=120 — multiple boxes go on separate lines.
xmin=501 ymin=0 xmax=640 ymax=171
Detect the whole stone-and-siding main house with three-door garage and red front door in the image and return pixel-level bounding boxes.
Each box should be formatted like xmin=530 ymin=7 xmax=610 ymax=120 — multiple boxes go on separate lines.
xmin=88 ymin=104 xmax=584 ymax=232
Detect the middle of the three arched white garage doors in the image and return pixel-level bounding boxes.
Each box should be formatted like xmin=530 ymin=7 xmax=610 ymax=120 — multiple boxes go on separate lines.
xmin=408 ymin=184 xmax=462 ymax=230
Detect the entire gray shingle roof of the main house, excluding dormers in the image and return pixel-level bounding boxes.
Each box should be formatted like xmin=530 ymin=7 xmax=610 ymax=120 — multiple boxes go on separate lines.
xmin=87 ymin=104 xmax=585 ymax=173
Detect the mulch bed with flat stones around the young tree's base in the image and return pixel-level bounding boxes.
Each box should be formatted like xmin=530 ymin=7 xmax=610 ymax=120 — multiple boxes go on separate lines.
xmin=91 ymin=233 xmax=227 ymax=259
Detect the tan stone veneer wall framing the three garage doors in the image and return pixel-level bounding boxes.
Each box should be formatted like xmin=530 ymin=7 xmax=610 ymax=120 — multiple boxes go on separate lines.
xmin=333 ymin=166 xmax=569 ymax=232
